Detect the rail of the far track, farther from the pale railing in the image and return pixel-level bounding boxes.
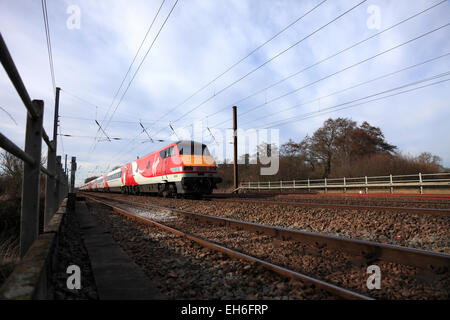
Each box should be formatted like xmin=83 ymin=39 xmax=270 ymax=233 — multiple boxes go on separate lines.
xmin=213 ymin=199 xmax=450 ymax=216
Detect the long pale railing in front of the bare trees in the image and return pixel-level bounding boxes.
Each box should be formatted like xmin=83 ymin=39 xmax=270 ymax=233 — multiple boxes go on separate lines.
xmin=239 ymin=173 xmax=450 ymax=194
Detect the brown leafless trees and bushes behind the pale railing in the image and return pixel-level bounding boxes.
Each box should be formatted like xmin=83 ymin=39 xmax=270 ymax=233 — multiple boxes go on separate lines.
xmin=218 ymin=118 xmax=445 ymax=188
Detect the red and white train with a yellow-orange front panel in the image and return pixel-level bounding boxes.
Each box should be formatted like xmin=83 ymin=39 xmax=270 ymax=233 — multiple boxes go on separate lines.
xmin=79 ymin=140 xmax=222 ymax=197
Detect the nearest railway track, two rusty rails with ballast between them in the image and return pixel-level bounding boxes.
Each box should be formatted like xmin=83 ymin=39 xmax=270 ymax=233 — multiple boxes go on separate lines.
xmin=81 ymin=194 xmax=450 ymax=299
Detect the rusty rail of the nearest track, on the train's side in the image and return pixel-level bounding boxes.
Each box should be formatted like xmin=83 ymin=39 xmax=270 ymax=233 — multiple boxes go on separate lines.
xmin=83 ymin=195 xmax=450 ymax=272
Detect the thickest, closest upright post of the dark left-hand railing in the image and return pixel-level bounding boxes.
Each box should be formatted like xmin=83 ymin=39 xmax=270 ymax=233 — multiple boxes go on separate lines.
xmin=20 ymin=100 xmax=44 ymax=257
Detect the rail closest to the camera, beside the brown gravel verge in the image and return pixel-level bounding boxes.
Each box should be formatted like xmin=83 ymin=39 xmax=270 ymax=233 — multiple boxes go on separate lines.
xmin=87 ymin=195 xmax=374 ymax=300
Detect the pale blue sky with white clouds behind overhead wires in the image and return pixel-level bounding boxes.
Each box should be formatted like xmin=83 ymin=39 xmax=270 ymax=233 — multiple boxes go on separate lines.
xmin=0 ymin=0 xmax=450 ymax=185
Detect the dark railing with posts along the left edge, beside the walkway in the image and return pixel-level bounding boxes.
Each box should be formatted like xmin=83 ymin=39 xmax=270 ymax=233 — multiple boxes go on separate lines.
xmin=0 ymin=33 xmax=73 ymax=257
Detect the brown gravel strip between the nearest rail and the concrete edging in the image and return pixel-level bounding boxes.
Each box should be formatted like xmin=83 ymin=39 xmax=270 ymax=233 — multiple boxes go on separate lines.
xmin=88 ymin=202 xmax=334 ymax=300
